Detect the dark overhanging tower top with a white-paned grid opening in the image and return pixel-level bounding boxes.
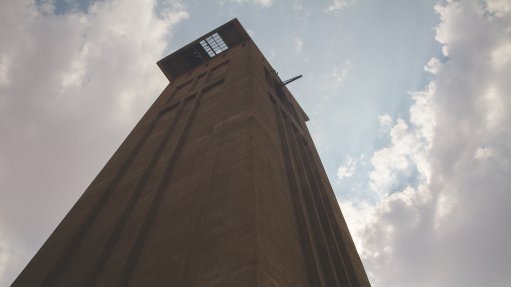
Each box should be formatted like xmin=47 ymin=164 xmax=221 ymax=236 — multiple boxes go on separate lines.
xmin=157 ymin=18 xmax=250 ymax=81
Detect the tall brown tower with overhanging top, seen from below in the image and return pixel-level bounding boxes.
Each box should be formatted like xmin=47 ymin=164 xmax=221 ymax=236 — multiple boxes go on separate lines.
xmin=13 ymin=19 xmax=369 ymax=287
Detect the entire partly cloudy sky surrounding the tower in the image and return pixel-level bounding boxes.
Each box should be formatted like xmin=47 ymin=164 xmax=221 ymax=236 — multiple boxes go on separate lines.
xmin=0 ymin=0 xmax=511 ymax=287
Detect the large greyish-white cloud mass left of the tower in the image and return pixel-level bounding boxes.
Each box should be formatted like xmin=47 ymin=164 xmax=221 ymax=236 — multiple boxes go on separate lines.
xmin=0 ymin=0 xmax=188 ymax=286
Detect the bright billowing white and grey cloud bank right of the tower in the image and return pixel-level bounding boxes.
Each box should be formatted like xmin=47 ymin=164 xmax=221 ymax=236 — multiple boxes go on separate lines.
xmin=342 ymin=0 xmax=511 ymax=287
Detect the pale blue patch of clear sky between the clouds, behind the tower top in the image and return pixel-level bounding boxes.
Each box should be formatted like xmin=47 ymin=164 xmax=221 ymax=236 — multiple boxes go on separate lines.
xmin=163 ymin=1 xmax=441 ymax=205
